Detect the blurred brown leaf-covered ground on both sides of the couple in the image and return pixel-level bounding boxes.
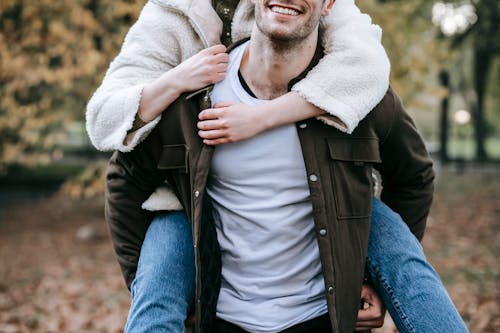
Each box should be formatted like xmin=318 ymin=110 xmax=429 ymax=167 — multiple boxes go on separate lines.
xmin=0 ymin=170 xmax=500 ymax=333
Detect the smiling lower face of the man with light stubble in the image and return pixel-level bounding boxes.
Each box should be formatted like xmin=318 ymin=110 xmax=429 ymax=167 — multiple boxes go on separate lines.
xmin=253 ymin=0 xmax=334 ymax=42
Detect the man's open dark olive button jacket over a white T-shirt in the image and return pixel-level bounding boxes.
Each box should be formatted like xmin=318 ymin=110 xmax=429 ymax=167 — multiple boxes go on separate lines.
xmin=106 ymin=81 xmax=434 ymax=332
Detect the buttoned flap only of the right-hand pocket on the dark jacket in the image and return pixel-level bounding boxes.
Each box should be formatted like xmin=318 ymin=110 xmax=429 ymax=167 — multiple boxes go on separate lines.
xmin=327 ymin=138 xmax=382 ymax=163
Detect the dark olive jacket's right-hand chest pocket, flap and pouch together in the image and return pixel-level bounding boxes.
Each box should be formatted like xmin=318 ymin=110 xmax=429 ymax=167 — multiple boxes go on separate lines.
xmin=327 ymin=138 xmax=381 ymax=219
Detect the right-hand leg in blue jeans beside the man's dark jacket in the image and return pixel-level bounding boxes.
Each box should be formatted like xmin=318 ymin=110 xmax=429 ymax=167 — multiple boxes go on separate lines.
xmin=367 ymin=199 xmax=468 ymax=333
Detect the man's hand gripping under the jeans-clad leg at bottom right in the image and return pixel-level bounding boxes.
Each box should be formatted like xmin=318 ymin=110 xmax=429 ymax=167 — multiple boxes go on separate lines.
xmin=356 ymin=284 xmax=385 ymax=331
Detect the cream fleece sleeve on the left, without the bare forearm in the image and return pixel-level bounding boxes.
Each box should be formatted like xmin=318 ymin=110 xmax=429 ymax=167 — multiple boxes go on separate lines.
xmin=86 ymin=1 xmax=197 ymax=152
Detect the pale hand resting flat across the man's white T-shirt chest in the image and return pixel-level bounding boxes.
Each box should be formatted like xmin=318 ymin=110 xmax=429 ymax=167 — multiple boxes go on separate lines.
xmin=198 ymin=102 xmax=266 ymax=145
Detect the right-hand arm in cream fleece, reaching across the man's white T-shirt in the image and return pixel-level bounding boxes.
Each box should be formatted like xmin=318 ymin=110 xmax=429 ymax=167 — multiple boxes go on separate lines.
xmin=199 ymin=0 xmax=390 ymax=145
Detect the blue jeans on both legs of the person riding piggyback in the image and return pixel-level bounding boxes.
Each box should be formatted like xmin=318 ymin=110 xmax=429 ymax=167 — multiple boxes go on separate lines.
xmin=125 ymin=199 xmax=468 ymax=333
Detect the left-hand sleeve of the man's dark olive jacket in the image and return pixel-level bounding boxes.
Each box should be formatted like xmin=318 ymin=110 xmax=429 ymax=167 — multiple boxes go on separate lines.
xmin=105 ymin=126 xmax=165 ymax=288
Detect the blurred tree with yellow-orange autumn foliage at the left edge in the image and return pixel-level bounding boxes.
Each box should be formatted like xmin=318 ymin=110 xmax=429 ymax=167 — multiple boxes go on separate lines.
xmin=0 ymin=0 xmax=144 ymax=173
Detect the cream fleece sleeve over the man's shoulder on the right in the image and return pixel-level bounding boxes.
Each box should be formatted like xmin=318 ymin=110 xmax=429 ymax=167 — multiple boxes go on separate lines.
xmin=292 ymin=0 xmax=390 ymax=133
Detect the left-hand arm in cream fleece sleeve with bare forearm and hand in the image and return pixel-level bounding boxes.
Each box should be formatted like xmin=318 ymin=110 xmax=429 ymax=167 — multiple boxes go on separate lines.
xmin=86 ymin=1 xmax=228 ymax=152
